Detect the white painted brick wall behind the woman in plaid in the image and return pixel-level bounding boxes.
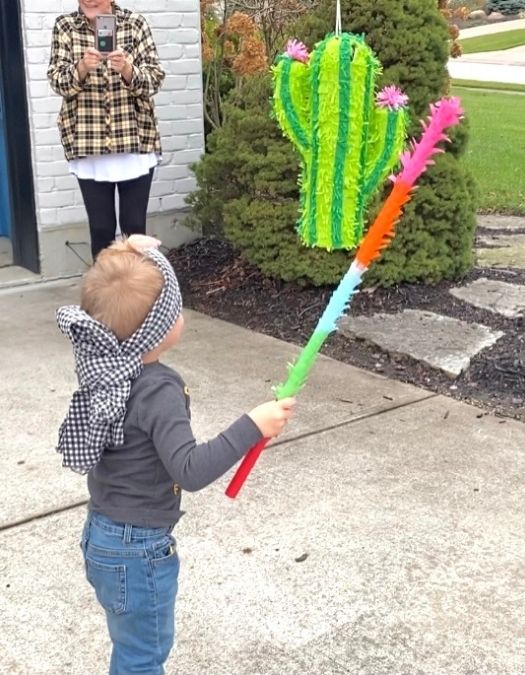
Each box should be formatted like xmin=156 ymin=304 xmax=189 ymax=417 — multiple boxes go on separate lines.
xmin=18 ymin=0 xmax=204 ymax=276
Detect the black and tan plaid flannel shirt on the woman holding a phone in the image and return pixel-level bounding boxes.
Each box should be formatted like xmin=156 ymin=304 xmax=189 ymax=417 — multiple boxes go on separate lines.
xmin=47 ymin=5 xmax=165 ymax=160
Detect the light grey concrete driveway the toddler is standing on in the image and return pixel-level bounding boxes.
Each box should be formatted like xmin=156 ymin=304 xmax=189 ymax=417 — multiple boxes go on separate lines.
xmin=0 ymin=284 xmax=525 ymax=675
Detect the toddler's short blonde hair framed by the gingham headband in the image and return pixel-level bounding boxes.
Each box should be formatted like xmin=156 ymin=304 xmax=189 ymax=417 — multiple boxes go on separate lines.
xmin=80 ymin=240 xmax=164 ymax=342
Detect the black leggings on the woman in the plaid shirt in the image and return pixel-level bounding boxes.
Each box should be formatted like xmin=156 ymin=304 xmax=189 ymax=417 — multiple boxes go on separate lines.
xmin=78 ymin=169 xmax=154 ymax=260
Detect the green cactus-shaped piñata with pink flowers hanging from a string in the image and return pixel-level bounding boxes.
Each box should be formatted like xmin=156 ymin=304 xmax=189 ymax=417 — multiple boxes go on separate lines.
xmin=273 ymin=33 xmax=408 ymax=250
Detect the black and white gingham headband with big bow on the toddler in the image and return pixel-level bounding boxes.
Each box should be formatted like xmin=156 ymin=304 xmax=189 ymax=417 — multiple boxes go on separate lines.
xmin=57 ymin=249 xmax=182 ymax=473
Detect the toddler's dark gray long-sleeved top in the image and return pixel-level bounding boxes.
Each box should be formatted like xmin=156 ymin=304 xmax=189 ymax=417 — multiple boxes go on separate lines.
xmin=88 ymin=363 xmax=261 ymax=527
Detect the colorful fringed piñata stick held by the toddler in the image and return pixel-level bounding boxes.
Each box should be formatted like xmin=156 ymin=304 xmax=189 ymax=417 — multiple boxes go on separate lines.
xmin=226 ymin=98 xmax=463 ymax=498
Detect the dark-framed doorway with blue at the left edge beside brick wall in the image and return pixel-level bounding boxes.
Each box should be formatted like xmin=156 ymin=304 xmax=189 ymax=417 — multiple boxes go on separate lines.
xmin=0 ymin=0 xmax=40 ymax=273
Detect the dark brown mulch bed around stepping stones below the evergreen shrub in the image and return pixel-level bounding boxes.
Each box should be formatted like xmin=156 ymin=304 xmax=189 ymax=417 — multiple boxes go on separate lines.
xmin=169 ymin=239 xmax=525 ymax=421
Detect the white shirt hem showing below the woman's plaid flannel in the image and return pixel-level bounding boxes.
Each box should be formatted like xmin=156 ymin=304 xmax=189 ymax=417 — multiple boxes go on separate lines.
xmin=69 ymin=152 xmax=160 ymax=183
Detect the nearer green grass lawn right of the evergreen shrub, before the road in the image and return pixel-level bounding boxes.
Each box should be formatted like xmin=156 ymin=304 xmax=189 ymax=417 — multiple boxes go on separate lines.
xmin=453 ymin=87 xmax=525 ymax=215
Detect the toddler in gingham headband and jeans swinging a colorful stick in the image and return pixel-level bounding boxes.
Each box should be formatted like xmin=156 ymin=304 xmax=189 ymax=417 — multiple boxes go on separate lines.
xmin=57 ymin=235 xmax=295 ymax=675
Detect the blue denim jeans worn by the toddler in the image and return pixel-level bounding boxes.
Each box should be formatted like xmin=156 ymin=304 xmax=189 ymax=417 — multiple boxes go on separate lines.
xmin=81 ymin=513 xmax=179 ymax=675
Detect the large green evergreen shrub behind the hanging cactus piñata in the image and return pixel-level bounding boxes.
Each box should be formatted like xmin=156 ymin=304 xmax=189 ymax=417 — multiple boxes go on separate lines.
xmin=190 ymin=0 xmax=476 ymax=285
